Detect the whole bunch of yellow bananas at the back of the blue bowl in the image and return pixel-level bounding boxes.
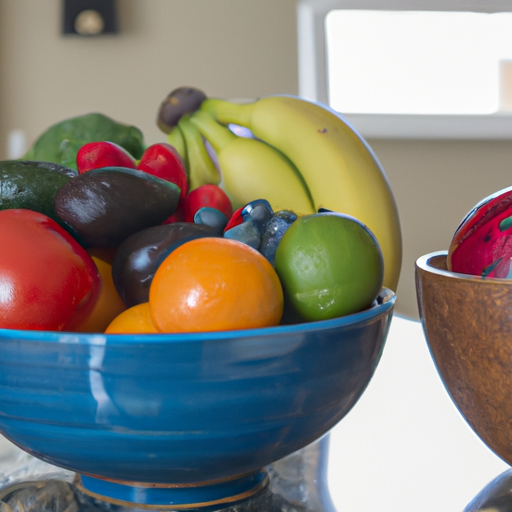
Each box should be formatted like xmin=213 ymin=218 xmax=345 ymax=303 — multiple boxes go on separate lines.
xmin=159 ymin=88 xmax=402 ymax=290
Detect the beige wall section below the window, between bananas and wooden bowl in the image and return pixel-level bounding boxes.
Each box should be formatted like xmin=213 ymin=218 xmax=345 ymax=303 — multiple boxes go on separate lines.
xmin=369 ymin=140 xmax=512 ymax=318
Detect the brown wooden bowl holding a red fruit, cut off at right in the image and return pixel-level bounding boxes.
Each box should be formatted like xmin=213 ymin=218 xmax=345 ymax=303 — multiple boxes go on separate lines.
xmin=416 ymin=252 xmax=512 ymax=464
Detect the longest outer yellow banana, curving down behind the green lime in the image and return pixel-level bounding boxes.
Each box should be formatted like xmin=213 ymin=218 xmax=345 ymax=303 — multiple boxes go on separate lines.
xmin=201 ymin=95 xmax=402 ymax=291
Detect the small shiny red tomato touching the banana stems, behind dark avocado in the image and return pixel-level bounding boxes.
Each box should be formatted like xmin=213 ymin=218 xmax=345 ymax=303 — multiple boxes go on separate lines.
xmin=137 ymin=142 xmax=188 ymax=199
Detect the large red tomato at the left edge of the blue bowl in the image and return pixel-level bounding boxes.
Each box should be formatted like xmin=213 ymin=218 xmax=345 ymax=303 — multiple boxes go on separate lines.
xmin=0 ymin=209 xmax=100 ymax=331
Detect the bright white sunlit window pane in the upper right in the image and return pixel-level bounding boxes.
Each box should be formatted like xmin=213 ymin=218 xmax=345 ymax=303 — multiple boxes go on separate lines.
xmin=326 ymin=10 xmax=512 ymax=114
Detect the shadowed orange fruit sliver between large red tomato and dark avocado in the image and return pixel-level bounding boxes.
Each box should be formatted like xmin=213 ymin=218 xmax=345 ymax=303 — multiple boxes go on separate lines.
xmin=75 ymin=255 xmax=126 ymax=332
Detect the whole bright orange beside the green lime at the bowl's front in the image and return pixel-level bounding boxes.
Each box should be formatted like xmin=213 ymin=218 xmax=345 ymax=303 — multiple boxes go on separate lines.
xmin=149 ymin=238 xmax=283 ymax=332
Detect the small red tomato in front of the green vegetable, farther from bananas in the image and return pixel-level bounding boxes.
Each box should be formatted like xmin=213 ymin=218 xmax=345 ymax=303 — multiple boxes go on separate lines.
xmin=76 ymin=141 xmax=135 ymax=174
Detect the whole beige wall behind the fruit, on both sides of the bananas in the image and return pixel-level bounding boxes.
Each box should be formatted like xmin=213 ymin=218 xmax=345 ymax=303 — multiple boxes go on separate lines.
xmin=0 ymin=0 xmax=512 ymax=317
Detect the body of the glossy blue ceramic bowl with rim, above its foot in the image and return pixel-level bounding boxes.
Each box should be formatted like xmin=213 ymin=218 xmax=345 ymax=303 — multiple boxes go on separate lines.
xmin=0 ymin=289 xmax=395 ymax=492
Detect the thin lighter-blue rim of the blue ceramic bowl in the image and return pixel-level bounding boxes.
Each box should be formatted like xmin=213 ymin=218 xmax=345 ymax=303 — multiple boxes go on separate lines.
xmin=0 ymin=287 xmax=396 ymax=346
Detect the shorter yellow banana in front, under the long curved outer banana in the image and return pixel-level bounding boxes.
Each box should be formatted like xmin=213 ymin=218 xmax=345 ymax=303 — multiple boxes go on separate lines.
xmin=190 ymin=110 xmax=315 ymax=215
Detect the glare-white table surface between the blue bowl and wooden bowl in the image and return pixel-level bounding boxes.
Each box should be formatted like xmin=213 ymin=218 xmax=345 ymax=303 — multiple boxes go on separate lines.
xmin=0 ymin=315 xmax=509 ymax=512
